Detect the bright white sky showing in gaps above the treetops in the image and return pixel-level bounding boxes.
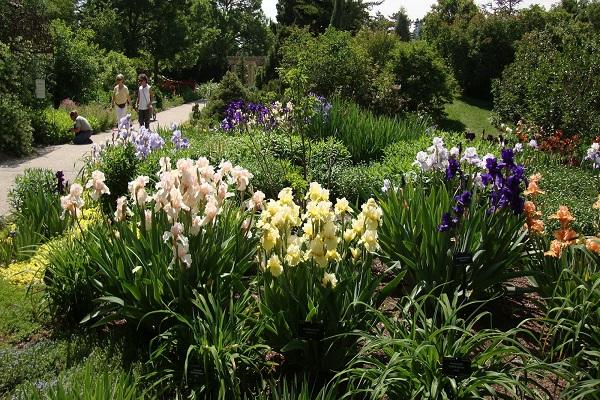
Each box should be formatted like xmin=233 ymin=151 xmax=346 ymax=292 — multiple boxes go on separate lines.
xmin=263 ymin=0 xmax=558 ymax=20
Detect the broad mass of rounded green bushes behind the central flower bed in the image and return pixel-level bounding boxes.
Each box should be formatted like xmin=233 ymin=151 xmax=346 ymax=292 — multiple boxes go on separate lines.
xmin=280 ymin=29 xmax=456 ymax=115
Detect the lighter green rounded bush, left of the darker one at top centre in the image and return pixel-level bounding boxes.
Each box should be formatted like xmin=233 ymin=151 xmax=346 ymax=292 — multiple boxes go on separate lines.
xmin=279 ymin=28 xmax=374 ymax=103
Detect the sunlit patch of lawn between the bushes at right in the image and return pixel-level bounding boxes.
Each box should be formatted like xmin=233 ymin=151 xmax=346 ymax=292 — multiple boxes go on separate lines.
xmin=440 ymin=97 xmax=500 ymax=137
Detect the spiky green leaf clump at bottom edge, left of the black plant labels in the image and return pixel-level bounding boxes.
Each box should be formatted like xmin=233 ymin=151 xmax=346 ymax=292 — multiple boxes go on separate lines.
xmin=148 ymin=291 xmax=269 ymax=399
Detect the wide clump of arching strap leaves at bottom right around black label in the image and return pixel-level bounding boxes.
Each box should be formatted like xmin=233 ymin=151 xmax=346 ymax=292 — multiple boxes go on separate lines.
xmin=337 ymin=291 xmax=545 ymax=399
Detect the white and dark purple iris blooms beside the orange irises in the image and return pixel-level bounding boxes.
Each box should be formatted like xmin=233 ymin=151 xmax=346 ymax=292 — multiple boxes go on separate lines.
xmin=414 ymin=137 xmax=527 ymax=232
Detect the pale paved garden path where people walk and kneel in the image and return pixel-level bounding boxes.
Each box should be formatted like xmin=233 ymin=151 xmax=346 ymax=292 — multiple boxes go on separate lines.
xmin=0 ymin=103 xmax=200 ymax=215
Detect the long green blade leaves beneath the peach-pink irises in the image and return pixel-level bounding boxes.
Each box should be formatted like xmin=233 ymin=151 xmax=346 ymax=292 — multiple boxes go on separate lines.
xmin=74 ymin=206 xmax=254 ymax=331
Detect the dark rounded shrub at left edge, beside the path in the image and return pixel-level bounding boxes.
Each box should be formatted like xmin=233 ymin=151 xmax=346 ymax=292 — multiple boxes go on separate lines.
xmin=0 ymin=95 xmax=33 ymax=156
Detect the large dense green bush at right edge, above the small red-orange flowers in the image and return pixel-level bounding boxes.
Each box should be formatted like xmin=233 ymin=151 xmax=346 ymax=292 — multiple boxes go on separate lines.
xmin=494 ymin=24 xmax=600 ymax=142
